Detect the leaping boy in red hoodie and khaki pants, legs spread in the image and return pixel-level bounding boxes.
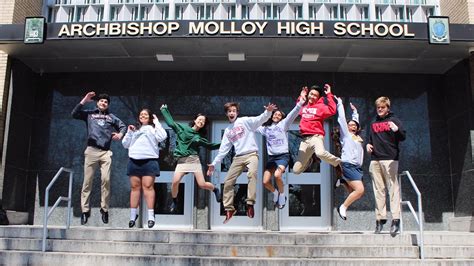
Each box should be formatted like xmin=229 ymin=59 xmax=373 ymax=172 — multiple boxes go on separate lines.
xmin=293 ymin=84 xmax=342 ymax=176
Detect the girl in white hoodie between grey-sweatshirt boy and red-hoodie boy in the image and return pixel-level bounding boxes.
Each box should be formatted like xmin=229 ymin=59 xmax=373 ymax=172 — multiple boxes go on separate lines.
xmin=257 ymin=90 xmax=306 ymax=209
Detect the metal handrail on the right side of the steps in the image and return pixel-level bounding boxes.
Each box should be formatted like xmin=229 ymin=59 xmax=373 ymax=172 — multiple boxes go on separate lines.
xmin=399 ymin=171 xmax=425 ymax=260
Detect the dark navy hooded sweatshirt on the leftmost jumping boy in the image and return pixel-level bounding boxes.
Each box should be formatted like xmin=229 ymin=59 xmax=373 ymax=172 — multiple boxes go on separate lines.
xmin=71 ymin=104 xmax=127 ymax=150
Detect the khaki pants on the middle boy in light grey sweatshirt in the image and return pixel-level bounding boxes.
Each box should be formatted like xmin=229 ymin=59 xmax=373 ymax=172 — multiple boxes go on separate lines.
xmin=222 ymin=152 xmax=258 ymax=211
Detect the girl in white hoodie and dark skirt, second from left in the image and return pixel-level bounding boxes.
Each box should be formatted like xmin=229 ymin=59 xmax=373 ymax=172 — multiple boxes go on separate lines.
xmin=122 ymin=109 xmax=167 ymax=228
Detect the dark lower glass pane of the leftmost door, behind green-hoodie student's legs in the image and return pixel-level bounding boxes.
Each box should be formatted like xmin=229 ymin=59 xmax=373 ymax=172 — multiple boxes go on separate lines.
xmin=156 ymin=183 xmax=184 ymax=215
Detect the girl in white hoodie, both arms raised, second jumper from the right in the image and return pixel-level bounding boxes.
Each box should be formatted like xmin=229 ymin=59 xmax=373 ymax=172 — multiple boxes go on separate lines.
xmin=335 ymin=98 xmax=364 ymax=220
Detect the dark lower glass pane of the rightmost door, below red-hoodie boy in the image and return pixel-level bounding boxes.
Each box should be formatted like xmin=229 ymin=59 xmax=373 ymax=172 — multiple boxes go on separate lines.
xmin=288 ymin=184 xmax=321 ymax=216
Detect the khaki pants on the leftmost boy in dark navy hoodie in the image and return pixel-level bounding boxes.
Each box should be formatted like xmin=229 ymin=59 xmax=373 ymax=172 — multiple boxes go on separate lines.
xmin=81 ymin=146 xmax=112 ymax=212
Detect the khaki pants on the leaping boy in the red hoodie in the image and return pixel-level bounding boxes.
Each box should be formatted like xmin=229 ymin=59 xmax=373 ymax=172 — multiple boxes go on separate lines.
xmin=293 ymin=135 xmax=341 ymax=174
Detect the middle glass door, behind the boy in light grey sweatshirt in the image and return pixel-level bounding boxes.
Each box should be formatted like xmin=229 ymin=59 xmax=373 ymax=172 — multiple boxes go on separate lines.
xmin=210 ymin=122 xmax=263 ymax=230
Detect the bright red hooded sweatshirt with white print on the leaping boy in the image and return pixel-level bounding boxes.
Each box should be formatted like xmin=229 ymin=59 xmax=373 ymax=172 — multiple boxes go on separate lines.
xmin=300 ymin=93 xmax=336 ymax=136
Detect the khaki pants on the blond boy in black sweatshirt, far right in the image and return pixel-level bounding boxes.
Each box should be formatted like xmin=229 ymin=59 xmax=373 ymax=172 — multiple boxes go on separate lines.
xmin=369 ymin=160 xmax=400 ymax=220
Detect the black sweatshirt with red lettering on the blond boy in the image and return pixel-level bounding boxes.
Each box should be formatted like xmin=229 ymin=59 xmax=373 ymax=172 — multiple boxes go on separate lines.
xmin=369 ymin=113 xmax=406 ymax=161
